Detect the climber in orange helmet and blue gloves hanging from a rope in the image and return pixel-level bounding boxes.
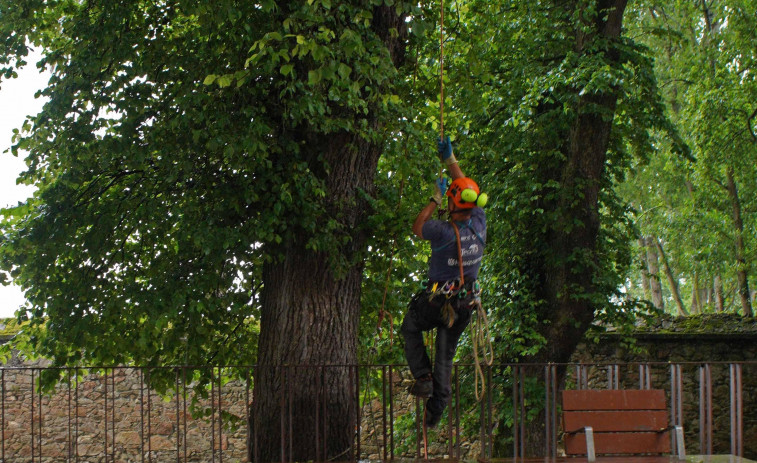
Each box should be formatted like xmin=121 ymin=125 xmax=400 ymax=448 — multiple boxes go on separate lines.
xmin=401 ymin=137 xmax=487 ymax=428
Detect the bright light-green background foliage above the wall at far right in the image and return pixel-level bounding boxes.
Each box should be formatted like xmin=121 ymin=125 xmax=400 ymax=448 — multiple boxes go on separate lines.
xmin=622 ymin=0 xmax=757 ymax=311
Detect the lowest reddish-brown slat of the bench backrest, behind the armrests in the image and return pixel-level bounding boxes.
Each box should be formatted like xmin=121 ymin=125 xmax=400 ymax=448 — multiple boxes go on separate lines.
xmin=565 ymin=432 xmax=670 ymax=455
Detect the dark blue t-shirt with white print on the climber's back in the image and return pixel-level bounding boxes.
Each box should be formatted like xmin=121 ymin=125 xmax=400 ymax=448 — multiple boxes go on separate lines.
xmin=422 ymin=207 xmax=486 ymax=281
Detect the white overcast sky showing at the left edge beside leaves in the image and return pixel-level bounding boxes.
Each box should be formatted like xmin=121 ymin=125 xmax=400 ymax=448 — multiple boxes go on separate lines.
xmin=0 ymin=52 xmax=49 ymax=318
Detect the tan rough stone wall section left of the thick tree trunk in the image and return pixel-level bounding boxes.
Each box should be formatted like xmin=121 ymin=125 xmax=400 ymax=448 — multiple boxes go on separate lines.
xmin=2 ymin=368 xmax=247 ymax=463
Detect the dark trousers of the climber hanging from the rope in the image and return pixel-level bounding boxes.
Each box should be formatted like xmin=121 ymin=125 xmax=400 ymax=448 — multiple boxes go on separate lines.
xmin=401 ymin=291 xmax=473 ymax=415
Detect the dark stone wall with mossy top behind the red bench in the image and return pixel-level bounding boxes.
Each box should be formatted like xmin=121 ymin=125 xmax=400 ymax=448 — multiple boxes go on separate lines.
xmin=573 ymin=333 xmax=757 ymax=459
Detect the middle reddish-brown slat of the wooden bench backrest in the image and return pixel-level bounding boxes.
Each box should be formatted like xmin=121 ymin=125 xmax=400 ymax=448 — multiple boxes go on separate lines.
xmin=563 ymin=410 xmax=668 ymax=433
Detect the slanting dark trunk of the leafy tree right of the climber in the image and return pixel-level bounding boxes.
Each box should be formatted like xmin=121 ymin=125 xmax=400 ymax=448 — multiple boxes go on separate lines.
xmin=524 ymin=0 xmax=627 ymax=457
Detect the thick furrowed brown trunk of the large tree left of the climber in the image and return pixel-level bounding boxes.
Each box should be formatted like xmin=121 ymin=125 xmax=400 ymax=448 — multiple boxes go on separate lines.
xmin=249 ymin=6 xmax=407 ymax=462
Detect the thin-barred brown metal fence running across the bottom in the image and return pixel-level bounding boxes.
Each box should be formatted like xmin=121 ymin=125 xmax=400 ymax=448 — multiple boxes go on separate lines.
xmin=0 ymin=361 xmax=757 ymax=463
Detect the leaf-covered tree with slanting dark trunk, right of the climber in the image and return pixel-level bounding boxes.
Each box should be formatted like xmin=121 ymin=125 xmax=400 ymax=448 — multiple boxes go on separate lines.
xmin=434 ymin=0 xmax=670 ymax=456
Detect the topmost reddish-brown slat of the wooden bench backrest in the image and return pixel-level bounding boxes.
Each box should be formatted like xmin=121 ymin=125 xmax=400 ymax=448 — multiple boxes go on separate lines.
xmin=562 ymin=389 xmax=666 ymax=410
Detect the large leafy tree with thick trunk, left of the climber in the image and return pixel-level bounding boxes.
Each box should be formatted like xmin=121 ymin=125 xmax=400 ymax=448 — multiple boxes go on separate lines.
xmin=0 ymin=0 xmax=410 ymax=460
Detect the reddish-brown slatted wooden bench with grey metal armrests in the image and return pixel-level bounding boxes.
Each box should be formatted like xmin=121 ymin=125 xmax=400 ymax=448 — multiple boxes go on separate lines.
xmin=562 ymin=389 xmax=686 ymax=462
